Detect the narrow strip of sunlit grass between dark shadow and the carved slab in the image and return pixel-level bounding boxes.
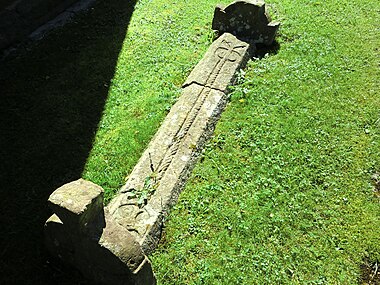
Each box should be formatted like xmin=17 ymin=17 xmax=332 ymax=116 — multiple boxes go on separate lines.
xmin=83 ymin=0 xmax=226 ymax=201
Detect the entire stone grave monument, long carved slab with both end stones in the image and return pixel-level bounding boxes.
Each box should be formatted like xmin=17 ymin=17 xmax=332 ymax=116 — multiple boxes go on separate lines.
xmin=45 ymin=0 xmax=279 ymax=285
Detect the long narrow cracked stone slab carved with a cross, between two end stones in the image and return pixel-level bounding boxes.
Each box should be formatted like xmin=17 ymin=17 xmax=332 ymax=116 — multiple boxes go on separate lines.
xmin=108 ymin=33 xmax=251 ymax=255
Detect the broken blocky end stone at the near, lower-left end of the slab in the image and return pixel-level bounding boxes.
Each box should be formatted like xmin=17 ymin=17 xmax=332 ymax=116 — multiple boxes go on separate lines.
xmin=44 ymin=179 xmax=156 ymax=285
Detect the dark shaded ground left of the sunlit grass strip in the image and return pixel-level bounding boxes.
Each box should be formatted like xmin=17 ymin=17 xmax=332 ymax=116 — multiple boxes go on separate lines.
xmin=0 ymin=0 xmax=136 ymax=284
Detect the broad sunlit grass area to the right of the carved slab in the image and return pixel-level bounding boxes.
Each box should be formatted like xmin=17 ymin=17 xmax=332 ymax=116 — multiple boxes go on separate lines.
xmin=146 ymin=1 xmax=380 ymax=284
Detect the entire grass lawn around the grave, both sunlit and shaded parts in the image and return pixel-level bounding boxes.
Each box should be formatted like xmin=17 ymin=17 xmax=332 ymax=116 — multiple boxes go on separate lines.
xmin=0 ymin=0 xmax=380 ymax=285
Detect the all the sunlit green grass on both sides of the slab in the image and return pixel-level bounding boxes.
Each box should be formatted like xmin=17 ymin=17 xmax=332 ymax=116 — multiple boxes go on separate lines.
xmin=83 ymin=0 xmax=380 ymax=284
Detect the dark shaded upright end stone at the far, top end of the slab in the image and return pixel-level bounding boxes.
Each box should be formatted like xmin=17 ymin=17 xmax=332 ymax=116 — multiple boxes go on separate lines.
xmin=212 ymin=0 xmax=280 ymax=45
